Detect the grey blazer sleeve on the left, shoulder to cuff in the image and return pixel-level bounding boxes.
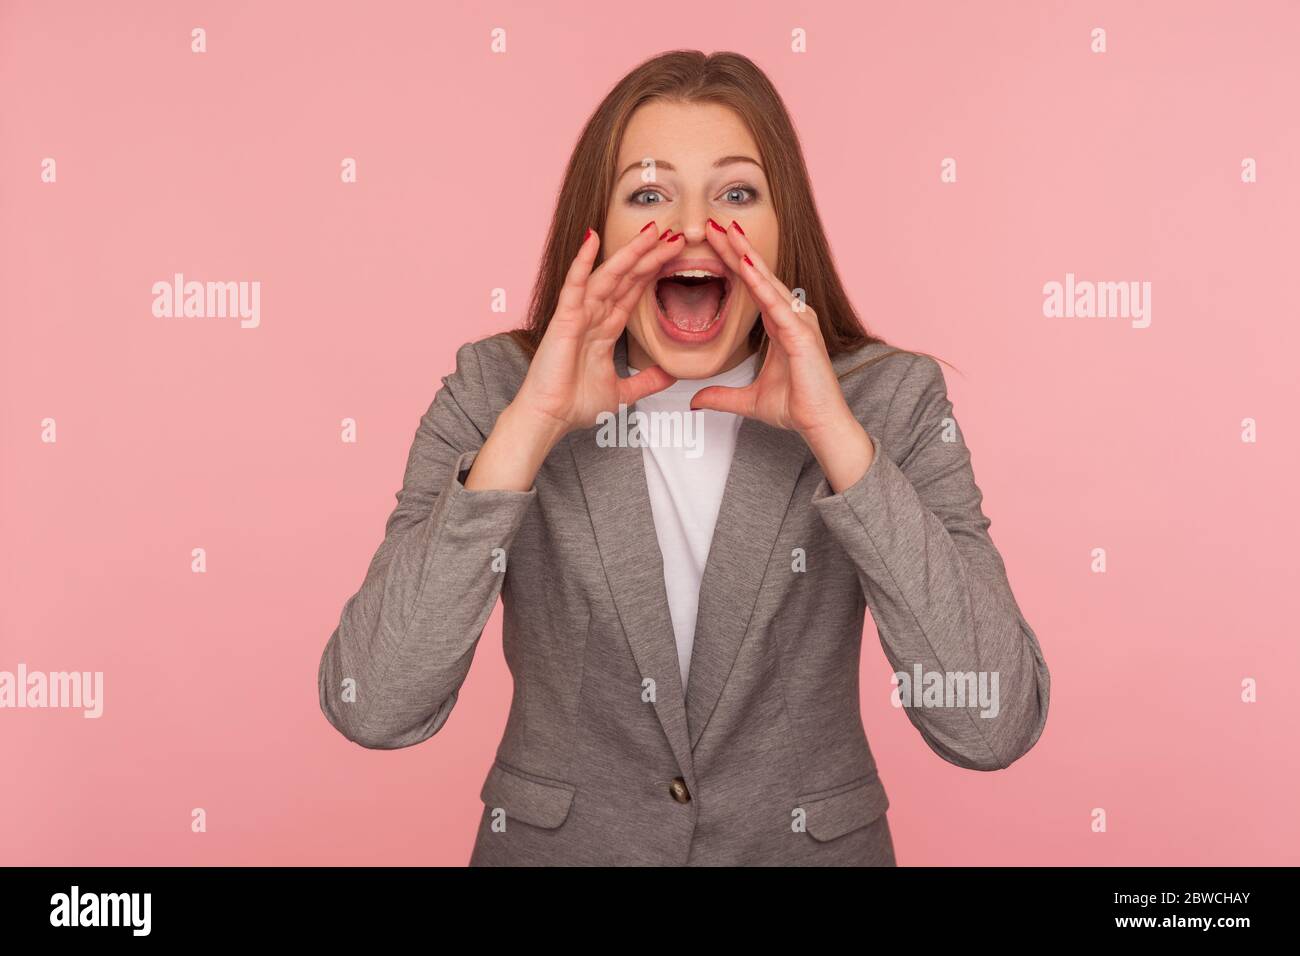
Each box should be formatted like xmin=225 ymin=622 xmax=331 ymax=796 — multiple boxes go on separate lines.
xmin=317 ymin=343 xmax=537 ymax=749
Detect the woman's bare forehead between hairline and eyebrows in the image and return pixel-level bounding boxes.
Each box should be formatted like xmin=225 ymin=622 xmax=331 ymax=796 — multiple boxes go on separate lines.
xmin=618 ymin=100 xmax=758 ymax=170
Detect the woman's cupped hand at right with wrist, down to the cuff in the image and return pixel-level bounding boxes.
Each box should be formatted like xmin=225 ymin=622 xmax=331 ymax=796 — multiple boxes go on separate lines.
xmin=690 ymin=220 xmax=875 ymax=492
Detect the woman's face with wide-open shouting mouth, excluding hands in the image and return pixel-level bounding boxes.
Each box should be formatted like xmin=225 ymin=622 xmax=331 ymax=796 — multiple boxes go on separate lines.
xmin=601 ymin=100 xmax=777 ymax=378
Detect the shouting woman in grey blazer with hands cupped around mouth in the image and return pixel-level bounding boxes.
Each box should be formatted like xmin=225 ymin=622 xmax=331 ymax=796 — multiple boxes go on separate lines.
xmin=319 ymin=51 xmax=1049 ymax=865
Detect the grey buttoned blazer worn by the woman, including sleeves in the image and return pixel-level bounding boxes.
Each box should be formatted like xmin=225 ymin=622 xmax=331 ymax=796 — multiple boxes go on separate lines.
xmin=319 ymin=336 xmax=1049 ymax=865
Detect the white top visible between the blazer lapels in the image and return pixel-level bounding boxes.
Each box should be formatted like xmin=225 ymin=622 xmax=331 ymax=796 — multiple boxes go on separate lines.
xmin=628 ymin=355 xmax=758 ymax=688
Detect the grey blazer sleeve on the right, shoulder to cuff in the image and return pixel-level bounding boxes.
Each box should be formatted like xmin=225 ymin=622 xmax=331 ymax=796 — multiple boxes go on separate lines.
xmin=814 ymin=355 xmax=1050 ymax=770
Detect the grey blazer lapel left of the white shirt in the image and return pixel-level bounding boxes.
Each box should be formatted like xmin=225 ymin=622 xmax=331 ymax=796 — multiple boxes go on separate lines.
xmin=569 ymin=334 xmax=694 ymax=778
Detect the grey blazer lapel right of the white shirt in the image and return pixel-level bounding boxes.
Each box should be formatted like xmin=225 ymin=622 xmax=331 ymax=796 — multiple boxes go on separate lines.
xmin=686 ymin=419 xmax=811 ymax=749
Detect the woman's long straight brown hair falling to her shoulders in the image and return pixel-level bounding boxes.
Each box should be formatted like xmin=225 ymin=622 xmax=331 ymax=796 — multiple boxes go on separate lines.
xmin=508 ymin=49 xmax=956 ymax=378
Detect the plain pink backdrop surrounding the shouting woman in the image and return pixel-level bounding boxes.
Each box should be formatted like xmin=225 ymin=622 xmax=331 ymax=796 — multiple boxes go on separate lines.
xmin=0 ymin=0 xmax=1300 ymax=865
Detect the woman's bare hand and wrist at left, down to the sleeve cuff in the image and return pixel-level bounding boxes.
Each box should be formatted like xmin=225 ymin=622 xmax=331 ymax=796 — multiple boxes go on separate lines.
xmin=465 ymin=220 xmax=683 ymax=492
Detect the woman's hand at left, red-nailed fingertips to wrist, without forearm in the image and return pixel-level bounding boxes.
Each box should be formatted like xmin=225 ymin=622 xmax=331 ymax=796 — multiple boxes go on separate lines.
xmin=511 ymin=220 xmax=681 ymax=441
